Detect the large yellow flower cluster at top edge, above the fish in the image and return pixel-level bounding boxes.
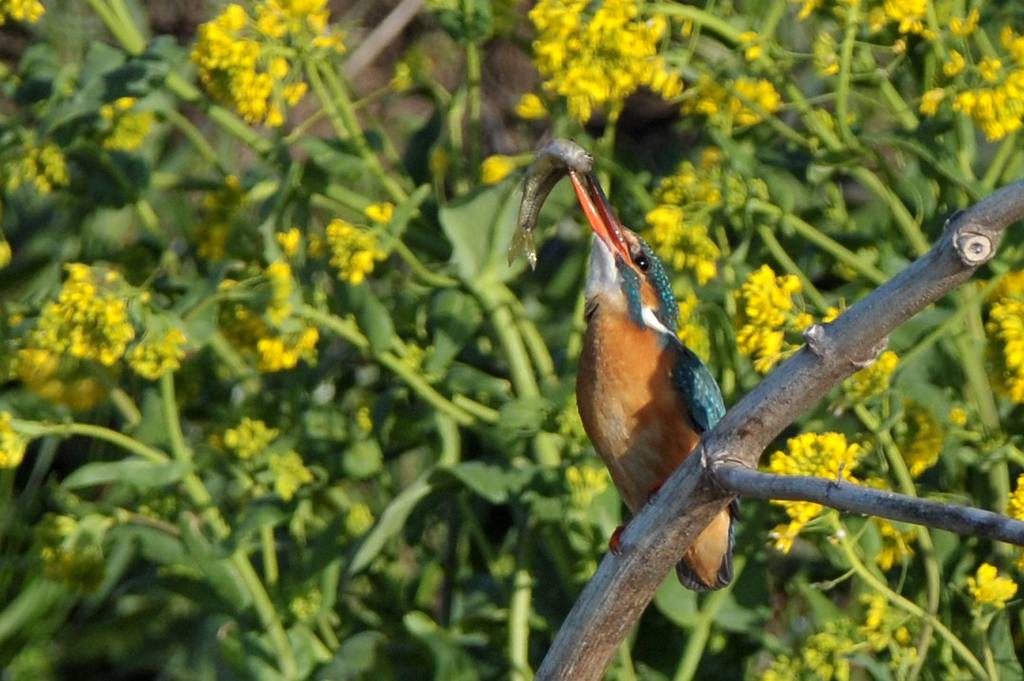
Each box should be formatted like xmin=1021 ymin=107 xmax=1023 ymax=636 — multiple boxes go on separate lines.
xmin=529 ymin=0 xmax=683 ymax=122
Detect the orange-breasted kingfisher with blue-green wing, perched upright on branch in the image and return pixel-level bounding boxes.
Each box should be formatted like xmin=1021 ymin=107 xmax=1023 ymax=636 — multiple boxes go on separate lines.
xmin=568 ymin=170 xmax=738 ymax=591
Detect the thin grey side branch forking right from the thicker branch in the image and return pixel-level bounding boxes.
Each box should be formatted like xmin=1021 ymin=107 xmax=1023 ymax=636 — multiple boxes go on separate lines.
xmin=715 ymin=465 xmax=1024 ymax=546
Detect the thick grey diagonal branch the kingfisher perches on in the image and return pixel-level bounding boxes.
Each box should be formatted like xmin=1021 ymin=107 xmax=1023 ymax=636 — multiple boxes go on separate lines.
xmin=537 ymin=182 xmax=1024 ymax=681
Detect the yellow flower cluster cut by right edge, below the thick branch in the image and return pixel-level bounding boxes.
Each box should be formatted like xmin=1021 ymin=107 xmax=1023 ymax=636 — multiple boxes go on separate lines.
xmin=985 ymin=271 xmax=1024 ymax=403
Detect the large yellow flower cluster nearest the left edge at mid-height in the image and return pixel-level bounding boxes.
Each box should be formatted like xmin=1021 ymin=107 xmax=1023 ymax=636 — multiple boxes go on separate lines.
xmin=28 ymin=262 xmax=135 ymax=367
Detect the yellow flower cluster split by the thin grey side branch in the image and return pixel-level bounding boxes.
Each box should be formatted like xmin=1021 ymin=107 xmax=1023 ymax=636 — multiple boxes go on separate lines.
xmin=768 ymin=432 xmax=863 ymax=553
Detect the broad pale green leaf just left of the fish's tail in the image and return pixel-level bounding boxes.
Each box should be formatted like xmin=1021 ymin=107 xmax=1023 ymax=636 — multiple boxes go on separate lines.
xmin=438 ymin=182 xmax=522 ymax=282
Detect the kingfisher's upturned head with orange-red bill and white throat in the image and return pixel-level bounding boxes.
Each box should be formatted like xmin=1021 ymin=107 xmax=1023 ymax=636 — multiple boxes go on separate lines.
xmin=569 ymin=171 xmax=679 ymax=335
